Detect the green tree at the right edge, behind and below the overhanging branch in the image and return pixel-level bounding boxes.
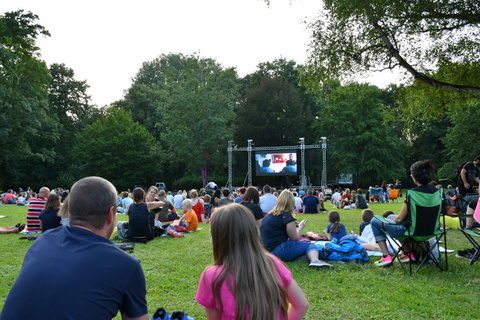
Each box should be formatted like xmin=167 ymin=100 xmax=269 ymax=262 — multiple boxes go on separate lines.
xmin=397 ymin=63 xmax=480 ymax=179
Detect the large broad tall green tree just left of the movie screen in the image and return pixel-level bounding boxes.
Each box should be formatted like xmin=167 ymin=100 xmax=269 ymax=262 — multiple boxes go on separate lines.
xmin=118 ymin=54 xmax=239 ymax=182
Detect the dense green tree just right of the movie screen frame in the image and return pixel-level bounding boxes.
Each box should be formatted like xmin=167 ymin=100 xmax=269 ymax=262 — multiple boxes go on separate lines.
xmin=314 ymin=83 xmax=408 ymax=186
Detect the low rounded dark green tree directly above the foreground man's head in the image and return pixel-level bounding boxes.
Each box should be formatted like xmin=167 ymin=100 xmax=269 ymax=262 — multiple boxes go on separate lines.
xmin=71 ymin=108 xmax=161 ymax=188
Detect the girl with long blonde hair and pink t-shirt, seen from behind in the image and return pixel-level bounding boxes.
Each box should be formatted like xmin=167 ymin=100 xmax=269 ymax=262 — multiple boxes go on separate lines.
xmin=196 ymin=203 xmax=309 ymax=320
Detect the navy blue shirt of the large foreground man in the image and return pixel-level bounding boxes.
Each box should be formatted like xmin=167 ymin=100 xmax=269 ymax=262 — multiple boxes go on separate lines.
xmin=0 ymin=227 xmax=148 ymax=320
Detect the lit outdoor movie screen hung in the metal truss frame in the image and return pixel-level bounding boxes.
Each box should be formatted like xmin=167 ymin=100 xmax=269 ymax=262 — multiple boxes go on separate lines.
xmin=255 ymin=150 xmax=298 ymax=176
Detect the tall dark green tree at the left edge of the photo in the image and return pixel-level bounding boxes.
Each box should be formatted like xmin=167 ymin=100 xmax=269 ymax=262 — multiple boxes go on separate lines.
xmin=0 ymin=10 xmax=58 ymax=187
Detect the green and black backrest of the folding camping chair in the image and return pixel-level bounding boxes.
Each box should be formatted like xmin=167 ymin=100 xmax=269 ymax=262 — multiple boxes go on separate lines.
xmin=405 ymin=189 xmax=443 ymax=241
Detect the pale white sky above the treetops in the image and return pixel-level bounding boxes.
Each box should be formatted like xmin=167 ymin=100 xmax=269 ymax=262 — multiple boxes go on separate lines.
xmin=0 ymin=0 xmax=400 ymax=106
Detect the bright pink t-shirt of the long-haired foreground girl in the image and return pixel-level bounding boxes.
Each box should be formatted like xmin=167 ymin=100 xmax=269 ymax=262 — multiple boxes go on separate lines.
xmin=195 ymin=255 xmax=292 ymax=320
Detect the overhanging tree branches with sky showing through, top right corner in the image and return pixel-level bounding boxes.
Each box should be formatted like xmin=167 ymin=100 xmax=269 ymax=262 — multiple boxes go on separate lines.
xmin=304 ymin=0 xmax=480 ymax=95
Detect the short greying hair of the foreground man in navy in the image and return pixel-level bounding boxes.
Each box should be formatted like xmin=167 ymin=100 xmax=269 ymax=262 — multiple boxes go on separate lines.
xmin=62 ymin=177 xmax=117 ymax=229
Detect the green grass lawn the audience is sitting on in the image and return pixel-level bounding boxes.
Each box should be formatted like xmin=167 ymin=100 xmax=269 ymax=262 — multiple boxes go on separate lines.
xmin=0 ymin=199 xmax=480 ymax=320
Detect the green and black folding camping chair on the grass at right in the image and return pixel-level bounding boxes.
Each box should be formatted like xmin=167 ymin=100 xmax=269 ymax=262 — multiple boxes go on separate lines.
xmin=375 ymin=189 xmax=448 ymax=275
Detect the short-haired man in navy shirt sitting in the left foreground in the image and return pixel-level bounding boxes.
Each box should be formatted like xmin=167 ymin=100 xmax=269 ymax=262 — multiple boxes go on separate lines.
xmin=0 ymin=177 xmax=148 ymax=320
